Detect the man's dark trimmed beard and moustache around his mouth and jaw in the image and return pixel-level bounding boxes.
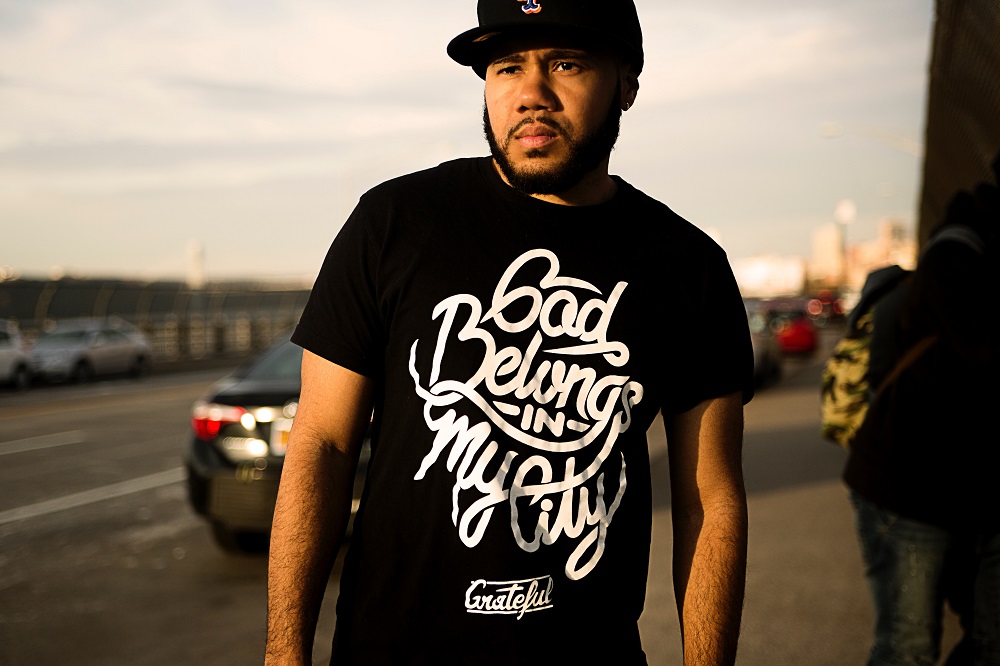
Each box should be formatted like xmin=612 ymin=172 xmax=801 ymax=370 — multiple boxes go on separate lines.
xmin=483 ymin=84 xmax=622 ymax=195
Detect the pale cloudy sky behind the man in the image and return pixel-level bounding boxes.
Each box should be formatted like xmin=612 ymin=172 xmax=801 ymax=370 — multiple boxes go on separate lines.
xmin=0 ymin=0 xmax=934 ymax=281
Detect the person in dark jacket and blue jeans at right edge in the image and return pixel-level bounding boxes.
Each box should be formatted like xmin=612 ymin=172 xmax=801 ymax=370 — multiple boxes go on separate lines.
xmin=844 ymin=158 xmax=1000 ymax=666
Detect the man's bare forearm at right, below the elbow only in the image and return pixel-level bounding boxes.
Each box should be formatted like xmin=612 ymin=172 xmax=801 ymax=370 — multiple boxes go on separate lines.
xmin=674 ymin=492 xmax=747 ymax=666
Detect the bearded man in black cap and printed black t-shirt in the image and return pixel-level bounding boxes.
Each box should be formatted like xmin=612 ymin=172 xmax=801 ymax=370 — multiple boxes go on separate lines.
xmin=267 ymin=0 xmax=752 ymax=664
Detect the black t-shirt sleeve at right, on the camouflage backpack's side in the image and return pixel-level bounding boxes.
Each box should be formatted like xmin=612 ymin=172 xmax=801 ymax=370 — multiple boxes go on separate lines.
xmin=663 ymin=246 xmax=754 ymax=414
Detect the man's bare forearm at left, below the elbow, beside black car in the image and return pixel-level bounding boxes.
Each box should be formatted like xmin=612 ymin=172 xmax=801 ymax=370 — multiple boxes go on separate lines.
xmin=265 ymin=441 xmax=355 ymax=665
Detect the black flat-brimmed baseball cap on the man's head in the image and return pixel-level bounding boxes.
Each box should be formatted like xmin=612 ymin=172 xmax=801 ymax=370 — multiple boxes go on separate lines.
xmin=448 ymin=0 xmax=643 ymax=78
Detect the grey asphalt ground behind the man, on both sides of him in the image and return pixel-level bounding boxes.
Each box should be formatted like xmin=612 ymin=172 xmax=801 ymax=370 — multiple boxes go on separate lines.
xmin=0 ymin=336 xmax=955 ymax=666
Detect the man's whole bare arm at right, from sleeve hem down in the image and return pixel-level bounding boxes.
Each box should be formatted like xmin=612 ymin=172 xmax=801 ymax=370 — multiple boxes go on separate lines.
xmin=664 ymin=393 xmax=747 ymax=666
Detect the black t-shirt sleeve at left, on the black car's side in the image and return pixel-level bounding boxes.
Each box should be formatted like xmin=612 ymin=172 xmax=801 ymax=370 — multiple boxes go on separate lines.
xmin=292 ymin=199 xmax=385 ymax=378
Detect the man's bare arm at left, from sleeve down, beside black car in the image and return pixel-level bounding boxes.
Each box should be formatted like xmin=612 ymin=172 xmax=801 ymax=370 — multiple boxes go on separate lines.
xmin=265 ymin=351 xmax=373 ymax=665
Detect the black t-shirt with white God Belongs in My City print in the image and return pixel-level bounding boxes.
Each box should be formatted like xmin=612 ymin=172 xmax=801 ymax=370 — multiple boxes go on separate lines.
xmin=292 ymin=158 xmax=753 ymax=664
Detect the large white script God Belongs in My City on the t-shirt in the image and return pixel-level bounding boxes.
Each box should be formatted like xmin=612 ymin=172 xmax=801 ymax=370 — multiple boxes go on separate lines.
xmin=410 ymin=249 xmax=643 ymax=580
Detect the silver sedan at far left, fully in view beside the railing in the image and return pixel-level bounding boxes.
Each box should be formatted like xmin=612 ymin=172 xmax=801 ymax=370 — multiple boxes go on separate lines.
xmin=31 ymin=323 xmax=150 ymax=382
